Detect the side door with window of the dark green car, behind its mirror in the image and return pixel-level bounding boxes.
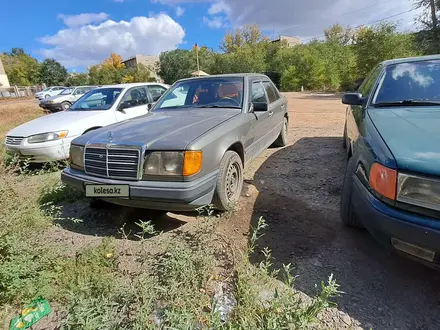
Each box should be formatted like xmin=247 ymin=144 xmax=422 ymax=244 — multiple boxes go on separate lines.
xmin=346 ymin=64 xmax=382 ymax=153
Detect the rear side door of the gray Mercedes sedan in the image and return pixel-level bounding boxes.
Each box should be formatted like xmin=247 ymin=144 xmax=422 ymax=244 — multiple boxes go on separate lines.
xmin=263 ymin=81 xmax=285 ymax=143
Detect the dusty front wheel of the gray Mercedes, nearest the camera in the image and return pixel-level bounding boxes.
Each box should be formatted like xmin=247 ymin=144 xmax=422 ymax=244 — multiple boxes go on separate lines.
xmin=213 ymin=150 xmax=243 ymax=211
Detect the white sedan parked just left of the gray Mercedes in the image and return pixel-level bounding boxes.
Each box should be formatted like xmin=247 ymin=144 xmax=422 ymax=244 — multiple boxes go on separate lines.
xmin=5 ymin=83 xmax=169 ymax=163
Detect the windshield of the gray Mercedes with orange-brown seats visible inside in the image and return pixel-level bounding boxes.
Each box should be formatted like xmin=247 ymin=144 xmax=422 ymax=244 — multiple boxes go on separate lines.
xmin=154 ymin=77 xmax=243 ymax=111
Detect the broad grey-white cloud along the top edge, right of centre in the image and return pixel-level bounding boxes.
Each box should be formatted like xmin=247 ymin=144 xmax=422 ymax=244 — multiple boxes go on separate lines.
xmin=156 ymin=0 xmax=420 ymax=38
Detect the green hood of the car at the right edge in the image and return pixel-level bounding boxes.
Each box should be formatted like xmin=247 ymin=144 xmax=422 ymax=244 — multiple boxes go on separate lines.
xmin=368 ymin=106 xmax=440 ymax=175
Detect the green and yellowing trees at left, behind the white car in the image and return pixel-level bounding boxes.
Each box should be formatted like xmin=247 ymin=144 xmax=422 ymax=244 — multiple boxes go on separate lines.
xmin=0 ymin=48 xmax=154 ymax=86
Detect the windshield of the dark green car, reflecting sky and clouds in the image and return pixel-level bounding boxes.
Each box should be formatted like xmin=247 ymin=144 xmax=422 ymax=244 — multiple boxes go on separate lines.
xmin=373 ymin=60 xmax=440 ymax=106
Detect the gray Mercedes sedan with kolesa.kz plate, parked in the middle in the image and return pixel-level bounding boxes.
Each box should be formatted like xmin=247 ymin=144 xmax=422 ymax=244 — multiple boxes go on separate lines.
xmin=61 ymin=74 xmax=289 ymax=211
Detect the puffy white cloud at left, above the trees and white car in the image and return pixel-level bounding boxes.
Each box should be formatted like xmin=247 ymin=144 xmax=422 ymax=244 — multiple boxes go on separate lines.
xmin=40 ymin=14 xmax=185 ymax=67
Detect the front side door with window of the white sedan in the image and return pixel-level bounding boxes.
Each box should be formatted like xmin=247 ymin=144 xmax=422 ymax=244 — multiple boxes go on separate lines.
xmin=116 ymin=86 xmax=151 ymax=121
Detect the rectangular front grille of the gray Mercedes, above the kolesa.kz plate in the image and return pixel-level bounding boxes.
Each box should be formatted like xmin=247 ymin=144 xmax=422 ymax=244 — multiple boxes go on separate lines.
xmin=84 ymin=146 xmax=140 ymax=180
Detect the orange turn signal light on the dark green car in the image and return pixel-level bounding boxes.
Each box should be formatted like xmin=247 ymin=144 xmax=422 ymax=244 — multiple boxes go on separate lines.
xmin=370 ymin=163 xmax=397 ymax=200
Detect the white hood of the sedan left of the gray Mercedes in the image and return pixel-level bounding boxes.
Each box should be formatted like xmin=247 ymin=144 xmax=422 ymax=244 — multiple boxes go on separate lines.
xmin=7 ymin=111 xmax=109 ymax=137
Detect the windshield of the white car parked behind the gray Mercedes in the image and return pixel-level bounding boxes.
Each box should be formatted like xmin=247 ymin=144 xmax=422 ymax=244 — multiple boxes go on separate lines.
xmin=69 ymin=88 xmax=122 ymax=111
